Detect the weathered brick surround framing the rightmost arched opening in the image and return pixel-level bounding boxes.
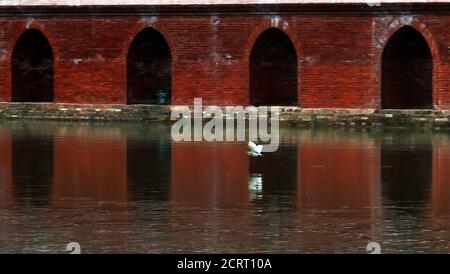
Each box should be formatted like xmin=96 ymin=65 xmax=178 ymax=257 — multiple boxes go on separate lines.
xmin=378 ymin=17 xmax=441 ymax=108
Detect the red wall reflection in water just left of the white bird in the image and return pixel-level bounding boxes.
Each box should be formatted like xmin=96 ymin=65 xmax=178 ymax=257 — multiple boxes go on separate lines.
xmin=171 ymin=142 xmax=249 ymax=208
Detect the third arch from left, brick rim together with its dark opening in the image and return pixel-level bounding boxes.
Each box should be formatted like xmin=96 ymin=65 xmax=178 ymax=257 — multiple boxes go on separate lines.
xmin=245 ymin=18 xmax=300 ymax=106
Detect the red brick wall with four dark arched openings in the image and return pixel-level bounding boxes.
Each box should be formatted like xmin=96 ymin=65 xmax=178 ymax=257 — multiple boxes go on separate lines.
xmin=0 ymin=5 xmax=450 ymax=109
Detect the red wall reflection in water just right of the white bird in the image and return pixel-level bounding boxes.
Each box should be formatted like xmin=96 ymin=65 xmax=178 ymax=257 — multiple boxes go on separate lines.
xmin=298 ymin=131 xmax=380 ymax=209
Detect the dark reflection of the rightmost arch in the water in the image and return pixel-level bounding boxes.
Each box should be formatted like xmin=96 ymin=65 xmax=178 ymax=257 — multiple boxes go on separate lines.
xmin=380 ymin=131 xmax=434 ymax=238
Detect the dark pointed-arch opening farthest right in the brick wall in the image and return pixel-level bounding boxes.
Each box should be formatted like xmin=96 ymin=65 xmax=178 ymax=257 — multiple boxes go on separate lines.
xmin=381 ymin=26 xmax=433 ymax=109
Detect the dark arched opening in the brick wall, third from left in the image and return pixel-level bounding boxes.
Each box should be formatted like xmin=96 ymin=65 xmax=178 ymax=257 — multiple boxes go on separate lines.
xmin=250 ymin=28 xmax=298 ymax=106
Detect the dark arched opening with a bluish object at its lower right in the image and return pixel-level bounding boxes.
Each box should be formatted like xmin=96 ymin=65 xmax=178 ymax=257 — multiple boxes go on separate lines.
xmin=127 ymin=28 xmax=172 ymax=104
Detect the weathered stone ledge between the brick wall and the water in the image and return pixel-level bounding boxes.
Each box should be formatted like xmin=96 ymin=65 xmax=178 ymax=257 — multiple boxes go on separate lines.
xmin=0 ymin=103 xmax=450 ymax=129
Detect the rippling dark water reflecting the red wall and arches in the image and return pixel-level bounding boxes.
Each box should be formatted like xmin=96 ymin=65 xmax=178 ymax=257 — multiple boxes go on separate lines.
xmin=0 ymin=121 xmax=450 ymax=253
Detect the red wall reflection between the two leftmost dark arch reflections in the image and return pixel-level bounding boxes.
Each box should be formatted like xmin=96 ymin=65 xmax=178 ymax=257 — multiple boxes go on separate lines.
xmin=54 ymin=125 xmax=127 ymax=201
